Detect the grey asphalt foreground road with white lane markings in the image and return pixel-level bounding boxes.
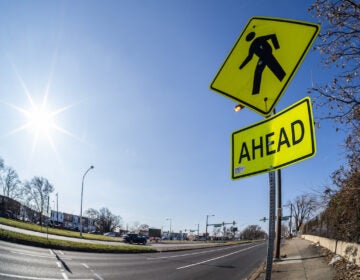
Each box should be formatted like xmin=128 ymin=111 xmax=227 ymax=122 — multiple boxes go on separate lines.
xmin=0 ymin=241 xmax=266 ymax=280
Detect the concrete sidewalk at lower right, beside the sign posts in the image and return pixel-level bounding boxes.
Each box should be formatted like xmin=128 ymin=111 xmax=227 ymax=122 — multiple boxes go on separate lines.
xmin=253 ymin=237 xmax=336 ymax=280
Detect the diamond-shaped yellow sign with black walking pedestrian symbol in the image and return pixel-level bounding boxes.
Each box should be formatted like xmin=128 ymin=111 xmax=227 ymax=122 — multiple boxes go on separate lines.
xmin=210 ymin=17 xmax=320 ymax=116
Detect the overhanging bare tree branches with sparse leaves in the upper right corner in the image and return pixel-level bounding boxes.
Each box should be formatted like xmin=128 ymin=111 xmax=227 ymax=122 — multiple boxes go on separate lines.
xmin=309 ymin=0 xmax=360 ymax=125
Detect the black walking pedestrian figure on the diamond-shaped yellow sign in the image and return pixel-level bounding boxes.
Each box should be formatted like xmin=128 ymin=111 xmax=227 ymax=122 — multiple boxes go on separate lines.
xmin=239 ymin=32 xmax=286 ymax=94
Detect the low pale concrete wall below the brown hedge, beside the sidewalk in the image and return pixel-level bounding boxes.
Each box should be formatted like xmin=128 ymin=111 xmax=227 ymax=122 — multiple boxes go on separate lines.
xmin=301 ymin=234 xmax=360 ymax=266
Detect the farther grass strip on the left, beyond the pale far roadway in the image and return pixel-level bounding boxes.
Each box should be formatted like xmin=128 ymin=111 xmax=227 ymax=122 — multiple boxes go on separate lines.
xmin=0 ymin=217 xmax=122 ymax=242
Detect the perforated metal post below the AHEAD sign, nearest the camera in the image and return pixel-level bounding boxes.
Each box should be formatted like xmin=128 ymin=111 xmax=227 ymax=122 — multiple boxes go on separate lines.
xmin=265 ymin=171 xmax=275 ymax=280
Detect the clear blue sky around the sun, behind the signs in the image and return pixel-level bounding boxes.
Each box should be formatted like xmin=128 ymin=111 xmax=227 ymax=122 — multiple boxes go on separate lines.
xmin=0 ymin=0 xmax=344 ymax=234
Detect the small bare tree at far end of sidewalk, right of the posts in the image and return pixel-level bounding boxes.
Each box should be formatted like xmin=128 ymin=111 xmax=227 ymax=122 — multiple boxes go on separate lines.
xmin=286 ymin=194 xmax=319 ymax=231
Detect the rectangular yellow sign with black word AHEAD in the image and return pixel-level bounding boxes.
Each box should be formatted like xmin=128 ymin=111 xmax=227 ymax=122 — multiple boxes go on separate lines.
xmin=231 ymin=97 xmax=316 ymax=179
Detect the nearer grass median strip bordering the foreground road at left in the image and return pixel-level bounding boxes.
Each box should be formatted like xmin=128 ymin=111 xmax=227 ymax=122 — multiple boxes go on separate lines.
xmin=0 ymin=229 xmax=156 ymax=253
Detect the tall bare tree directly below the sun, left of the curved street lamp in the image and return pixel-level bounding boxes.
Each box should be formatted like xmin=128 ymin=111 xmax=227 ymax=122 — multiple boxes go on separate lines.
xmin=24 ymin=177 xmax=54 ymax=225
